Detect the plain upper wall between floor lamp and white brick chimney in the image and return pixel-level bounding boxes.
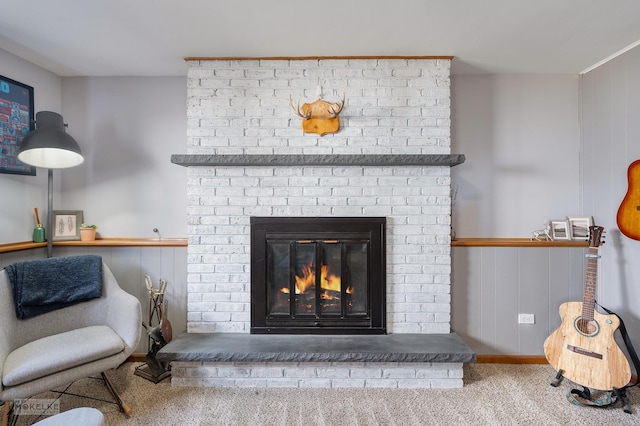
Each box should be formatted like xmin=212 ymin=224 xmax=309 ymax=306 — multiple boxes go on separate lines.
xmin=59 ymin=77 xmax=187 ymax=238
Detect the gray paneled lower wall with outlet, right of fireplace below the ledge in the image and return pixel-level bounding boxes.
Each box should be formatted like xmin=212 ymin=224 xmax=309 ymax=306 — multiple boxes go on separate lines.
xmin=451 ymin=247 xmax=585 ymax=355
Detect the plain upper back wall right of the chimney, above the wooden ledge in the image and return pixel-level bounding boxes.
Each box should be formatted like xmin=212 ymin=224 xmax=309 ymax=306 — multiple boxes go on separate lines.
xmin=451 ymin=75 xmax=580 ymax=238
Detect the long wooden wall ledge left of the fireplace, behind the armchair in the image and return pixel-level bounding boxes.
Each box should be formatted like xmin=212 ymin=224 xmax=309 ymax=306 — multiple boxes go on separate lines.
xmin=0 ymin=238 xmax=187 ymax=253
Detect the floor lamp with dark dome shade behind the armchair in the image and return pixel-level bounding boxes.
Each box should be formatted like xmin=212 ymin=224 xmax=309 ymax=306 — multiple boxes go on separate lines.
xmin=18 ymin=111 xmax=84 ymax=257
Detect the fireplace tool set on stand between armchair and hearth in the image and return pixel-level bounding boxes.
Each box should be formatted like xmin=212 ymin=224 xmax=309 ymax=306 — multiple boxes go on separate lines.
xmin=135 ymin=275 xmax=173 ymax=383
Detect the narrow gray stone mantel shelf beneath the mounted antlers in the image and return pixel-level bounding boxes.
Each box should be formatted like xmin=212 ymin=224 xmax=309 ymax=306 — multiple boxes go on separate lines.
xmin=171 ymin=154 xmax=465 ymax=167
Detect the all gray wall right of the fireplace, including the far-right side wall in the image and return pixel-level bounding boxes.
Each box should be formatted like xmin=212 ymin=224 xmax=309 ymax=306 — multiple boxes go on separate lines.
xmin=452 ymin=62 xmax=640 ymax=355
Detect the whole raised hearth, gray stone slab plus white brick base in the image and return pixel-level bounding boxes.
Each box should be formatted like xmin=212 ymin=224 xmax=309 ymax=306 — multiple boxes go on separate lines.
xmin=158 ymin=333 xmax=476 ymax=388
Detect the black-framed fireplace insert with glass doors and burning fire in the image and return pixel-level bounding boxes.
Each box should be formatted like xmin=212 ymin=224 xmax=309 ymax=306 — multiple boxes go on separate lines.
xmin=251 ymin=217 xmax=386 ymax=334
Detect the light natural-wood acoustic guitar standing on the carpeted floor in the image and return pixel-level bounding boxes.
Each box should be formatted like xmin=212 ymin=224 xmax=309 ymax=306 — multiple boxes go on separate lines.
xmin=544 ymin=226 xmax=631 ymax=390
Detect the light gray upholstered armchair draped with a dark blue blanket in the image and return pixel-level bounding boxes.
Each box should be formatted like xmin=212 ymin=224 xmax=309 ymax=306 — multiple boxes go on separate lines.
xmin=0 ymin=256 xmax=142 ymax=423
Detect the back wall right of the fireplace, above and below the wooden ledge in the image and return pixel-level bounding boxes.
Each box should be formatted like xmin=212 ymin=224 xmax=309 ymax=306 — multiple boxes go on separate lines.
xmin=451 ymin=75 xmax=584 ymax=355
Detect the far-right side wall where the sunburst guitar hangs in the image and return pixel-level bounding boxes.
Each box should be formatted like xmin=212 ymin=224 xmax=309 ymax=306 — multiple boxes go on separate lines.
xmin=580 ymin=47 xmax=640 ymax=345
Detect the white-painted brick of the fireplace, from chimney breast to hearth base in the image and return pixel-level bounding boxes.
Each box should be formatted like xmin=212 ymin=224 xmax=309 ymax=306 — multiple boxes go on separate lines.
xmin=168 ymin=57 xmax=475 ymax=387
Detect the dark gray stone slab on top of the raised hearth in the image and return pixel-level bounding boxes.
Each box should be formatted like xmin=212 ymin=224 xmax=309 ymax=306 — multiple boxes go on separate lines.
xmin=158 ymin=333 xmax=476 ymax=363
